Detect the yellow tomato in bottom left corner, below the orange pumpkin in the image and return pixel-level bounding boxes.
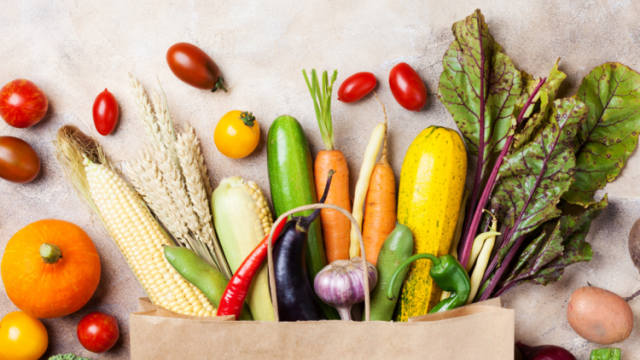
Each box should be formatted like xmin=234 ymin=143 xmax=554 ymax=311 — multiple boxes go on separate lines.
xmin=0 ymin=311 xmax=49 ymax=360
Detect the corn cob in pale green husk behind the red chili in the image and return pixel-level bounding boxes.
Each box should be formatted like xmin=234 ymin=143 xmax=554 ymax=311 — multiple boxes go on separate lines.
xmin=211 ymin=176 xmax=275 ymax=321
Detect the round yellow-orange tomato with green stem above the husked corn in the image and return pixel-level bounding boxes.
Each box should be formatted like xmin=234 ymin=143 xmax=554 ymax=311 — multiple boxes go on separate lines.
xmin=213 ymin=110 xmax=260 ymax=159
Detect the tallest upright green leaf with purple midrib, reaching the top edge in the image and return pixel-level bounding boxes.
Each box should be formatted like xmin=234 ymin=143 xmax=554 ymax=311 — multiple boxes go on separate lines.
xmin=438 ymin=10 xmax=523 ymax=180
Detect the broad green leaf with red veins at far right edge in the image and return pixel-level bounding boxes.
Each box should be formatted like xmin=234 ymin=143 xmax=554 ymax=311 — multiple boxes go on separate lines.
xmin=564 ymin=63 xmax=640 ymax=206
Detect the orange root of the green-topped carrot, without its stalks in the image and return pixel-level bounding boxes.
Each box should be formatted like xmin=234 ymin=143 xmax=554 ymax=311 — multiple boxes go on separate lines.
xmin=314 ymin=150 xmax=351 ymax=263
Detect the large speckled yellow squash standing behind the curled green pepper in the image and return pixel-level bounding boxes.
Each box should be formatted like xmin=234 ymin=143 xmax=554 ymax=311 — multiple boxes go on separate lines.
xmin=396 ymin=126 xmax=467 ymax=321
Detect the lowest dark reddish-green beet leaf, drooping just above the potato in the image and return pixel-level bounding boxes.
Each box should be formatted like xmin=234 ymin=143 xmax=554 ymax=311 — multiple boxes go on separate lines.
xmin=509 ymin=196 xmax=608 ymax=285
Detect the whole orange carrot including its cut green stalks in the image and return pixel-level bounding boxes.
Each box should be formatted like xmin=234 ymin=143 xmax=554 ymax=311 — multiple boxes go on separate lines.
xmin=302 ymin=69 xmax=351 ymax=263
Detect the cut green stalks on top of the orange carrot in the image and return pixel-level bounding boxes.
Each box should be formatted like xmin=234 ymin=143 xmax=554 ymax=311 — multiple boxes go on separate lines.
xmin=302 ymin=69 xmax=338 ymax=150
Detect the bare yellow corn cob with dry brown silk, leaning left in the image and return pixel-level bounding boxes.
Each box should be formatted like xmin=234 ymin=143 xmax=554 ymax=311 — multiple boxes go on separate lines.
xmin=56 ymin=125 xmax=216 ymax=316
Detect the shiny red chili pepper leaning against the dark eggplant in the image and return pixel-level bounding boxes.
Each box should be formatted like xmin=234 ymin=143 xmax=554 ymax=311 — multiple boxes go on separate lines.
xmin=218 ymin=220 xmax=287 ymax=320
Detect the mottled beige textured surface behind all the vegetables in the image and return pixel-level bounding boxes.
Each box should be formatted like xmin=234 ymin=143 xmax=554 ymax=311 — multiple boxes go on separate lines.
xmin=0 ymin=0 xmax=640 ymax=359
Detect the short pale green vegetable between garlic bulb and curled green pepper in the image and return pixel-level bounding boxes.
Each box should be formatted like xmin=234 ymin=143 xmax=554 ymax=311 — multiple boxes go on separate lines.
xmin=363 ymin=224 xmax=413 ymax=321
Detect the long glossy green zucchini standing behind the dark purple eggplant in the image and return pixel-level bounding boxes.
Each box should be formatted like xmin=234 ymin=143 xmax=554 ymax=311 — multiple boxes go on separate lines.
xmin=267 ymin=115 xmax=340 ymax=319
